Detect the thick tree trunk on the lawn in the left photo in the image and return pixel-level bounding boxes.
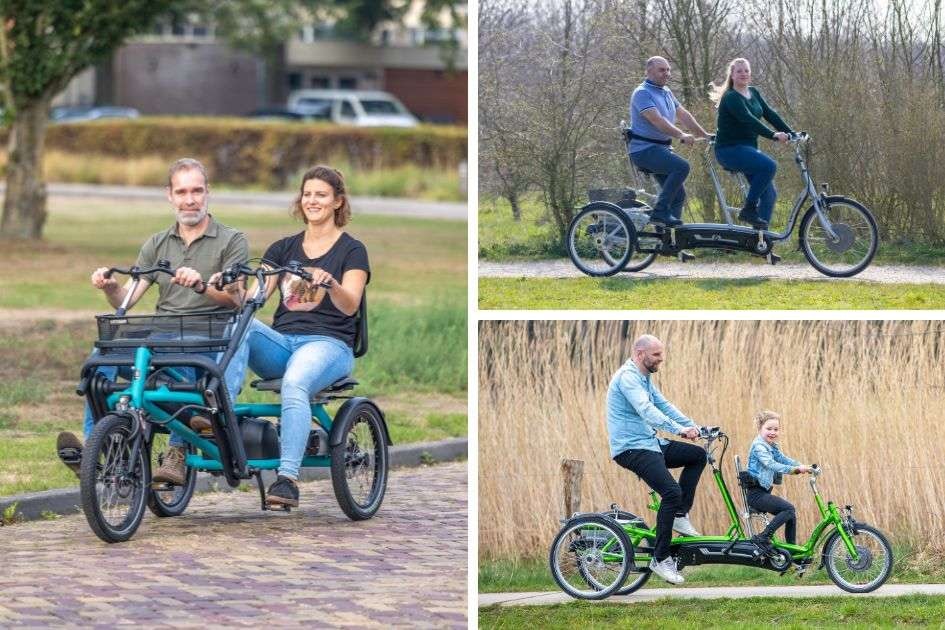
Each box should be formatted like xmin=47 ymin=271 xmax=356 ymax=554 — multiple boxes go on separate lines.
xmin=0 ymin=98 xmax=49 ymax=240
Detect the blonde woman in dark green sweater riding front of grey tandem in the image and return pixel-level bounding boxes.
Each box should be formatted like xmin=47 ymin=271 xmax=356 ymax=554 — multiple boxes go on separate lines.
xmin=710 ymin=58 xmax=794 ymax=230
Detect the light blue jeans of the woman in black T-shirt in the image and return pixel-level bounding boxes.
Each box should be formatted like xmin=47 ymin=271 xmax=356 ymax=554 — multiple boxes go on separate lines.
xmin=233 ymin=319 xmax=354 ymax=479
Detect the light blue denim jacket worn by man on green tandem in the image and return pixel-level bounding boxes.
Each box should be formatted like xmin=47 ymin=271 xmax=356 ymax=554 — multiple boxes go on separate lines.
xmin=607 ymin=359 xmax=696 ymax=457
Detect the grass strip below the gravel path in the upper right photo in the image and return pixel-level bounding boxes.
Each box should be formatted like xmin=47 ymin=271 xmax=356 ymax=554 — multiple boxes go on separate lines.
xmin=479 ymin=277 xmax=945 ymax=310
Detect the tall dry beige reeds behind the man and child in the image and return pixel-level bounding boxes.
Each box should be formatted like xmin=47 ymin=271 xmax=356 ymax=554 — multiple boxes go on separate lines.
xmin=479 ymin=321 xmax=945 ymax=559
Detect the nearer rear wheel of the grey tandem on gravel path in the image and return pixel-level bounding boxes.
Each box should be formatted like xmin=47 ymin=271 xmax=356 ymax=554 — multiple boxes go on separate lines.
xmin=566 ymin=204 xmax=636 ymax=277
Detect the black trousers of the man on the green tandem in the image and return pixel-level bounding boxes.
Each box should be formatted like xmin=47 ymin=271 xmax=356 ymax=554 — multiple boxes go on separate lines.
xmin=614 ymin=440 xmax=706 ymax=562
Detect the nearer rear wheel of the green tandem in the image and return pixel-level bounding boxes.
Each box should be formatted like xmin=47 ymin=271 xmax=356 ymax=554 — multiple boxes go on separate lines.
xmin=548 ymin=516 xmax=633 ymax=599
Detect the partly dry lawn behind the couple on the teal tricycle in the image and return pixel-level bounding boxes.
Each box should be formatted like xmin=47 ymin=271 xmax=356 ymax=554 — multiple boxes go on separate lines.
xmin=0 ymin=198 xmax=468 ymax=496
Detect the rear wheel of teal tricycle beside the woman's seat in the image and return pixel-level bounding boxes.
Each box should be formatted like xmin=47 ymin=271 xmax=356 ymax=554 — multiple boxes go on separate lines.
xmin=331 ymin=402 xmax=388 ymax=521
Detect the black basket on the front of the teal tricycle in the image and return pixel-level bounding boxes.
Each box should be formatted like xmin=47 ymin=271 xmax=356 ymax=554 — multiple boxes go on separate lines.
xmin=95 ymin=311 xmax=238 ymax=353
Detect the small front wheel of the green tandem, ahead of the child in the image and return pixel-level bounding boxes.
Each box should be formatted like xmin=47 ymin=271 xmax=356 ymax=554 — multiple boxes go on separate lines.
xmin=824 ymin=524 xmax=893 ymax=593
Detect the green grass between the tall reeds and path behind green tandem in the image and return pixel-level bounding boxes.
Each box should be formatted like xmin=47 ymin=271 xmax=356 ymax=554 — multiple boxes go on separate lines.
xmin=479 ymin=545 xmax=945 ymax=593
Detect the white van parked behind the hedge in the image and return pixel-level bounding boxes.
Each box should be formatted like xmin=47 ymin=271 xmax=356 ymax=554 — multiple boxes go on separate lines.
xmin=287 ymin=90 xmax=417 ymax=127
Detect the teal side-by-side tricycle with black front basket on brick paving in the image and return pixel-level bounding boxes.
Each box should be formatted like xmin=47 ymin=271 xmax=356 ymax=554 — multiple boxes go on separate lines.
xmin=77 ymin=261 xmax=391 ymax=543
